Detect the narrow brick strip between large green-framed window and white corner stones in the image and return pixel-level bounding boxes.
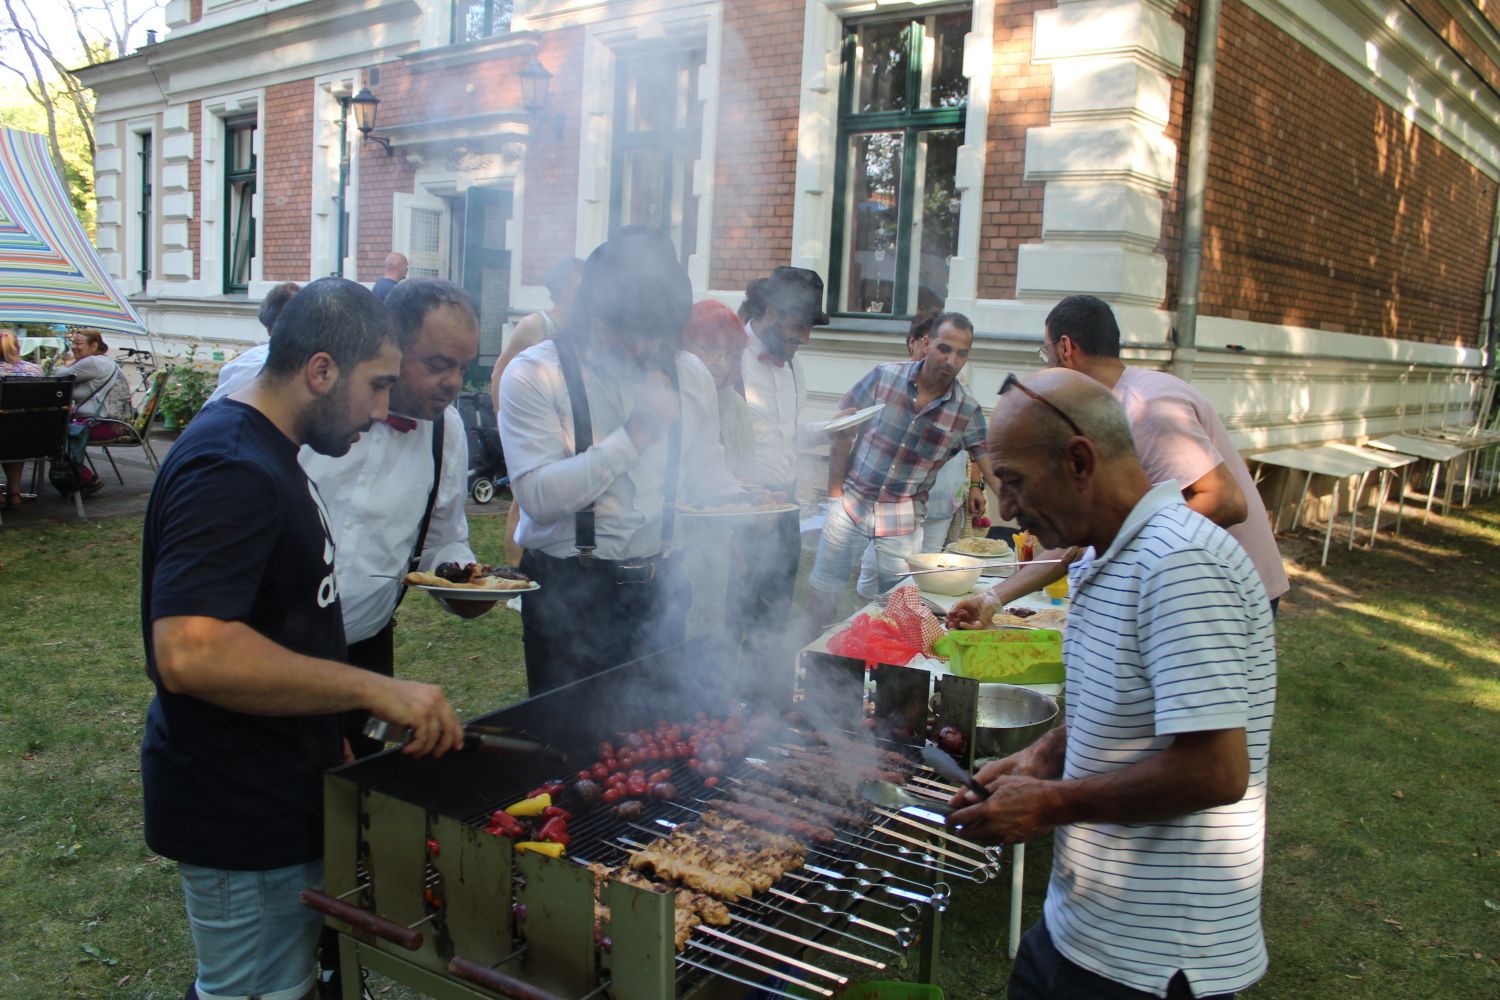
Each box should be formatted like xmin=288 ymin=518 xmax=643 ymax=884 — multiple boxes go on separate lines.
xmin=978 ymin=0 xmax=1053 ymax=298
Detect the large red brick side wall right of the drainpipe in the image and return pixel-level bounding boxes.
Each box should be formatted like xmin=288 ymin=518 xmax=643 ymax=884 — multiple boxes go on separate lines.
xmin=1172 ymin=0 xmax=1496 ymax=345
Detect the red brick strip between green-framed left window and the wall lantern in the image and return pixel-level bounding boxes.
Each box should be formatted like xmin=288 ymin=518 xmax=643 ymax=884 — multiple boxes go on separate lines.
xmin=260 ymin=79 xmax=314 ymax=282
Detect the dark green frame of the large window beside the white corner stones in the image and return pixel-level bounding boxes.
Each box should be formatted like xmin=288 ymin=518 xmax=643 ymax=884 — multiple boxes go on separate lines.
xmin=827 ymin=6 xmax=972 ymax=319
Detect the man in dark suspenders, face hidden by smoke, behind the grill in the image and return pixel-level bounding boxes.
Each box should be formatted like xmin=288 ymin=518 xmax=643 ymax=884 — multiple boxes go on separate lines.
xmin=500 ymin=226 xmax=744 ymax=696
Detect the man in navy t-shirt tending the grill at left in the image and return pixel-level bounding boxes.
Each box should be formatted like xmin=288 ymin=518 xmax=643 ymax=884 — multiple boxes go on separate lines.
xmin=141 ymin=277 xmax=464 ymax=1000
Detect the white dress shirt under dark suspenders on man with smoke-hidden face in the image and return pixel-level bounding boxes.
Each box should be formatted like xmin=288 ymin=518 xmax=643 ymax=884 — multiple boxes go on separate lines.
xmin=500 ymin=340 xmax=741 ymax=561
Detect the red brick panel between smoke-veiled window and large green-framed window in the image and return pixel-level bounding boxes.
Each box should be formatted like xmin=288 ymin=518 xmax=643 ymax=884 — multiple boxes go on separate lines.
xmin=708 ymin=0 xmax=803 ymax=289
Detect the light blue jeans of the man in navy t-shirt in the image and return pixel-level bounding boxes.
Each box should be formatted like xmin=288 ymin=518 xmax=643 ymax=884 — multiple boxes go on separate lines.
xmin=179 ymin=861 xmax=323 ymax=1000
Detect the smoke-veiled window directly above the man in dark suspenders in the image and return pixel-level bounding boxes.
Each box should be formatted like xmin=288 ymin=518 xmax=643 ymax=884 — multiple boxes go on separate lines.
xmin=609 ymin=48 xmax=704 ymax=264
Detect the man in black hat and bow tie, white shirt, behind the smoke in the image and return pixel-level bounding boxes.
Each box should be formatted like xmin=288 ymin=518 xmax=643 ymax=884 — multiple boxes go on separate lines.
xmin=731 ymin=267 xmax=828 ymax=667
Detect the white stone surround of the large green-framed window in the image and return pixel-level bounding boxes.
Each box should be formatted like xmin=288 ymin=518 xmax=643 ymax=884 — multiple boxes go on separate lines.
xmin=786 ymin=0 xmax=995 ymax=312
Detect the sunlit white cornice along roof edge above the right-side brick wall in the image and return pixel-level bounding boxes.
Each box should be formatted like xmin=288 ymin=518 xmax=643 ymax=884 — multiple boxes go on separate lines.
xmin=1245 ymin=0 xmax=1500 ymax=180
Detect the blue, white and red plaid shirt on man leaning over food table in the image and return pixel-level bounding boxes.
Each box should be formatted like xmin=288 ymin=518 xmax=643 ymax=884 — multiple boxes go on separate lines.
xmin=839 ymin=361 xmax=984 ymax=537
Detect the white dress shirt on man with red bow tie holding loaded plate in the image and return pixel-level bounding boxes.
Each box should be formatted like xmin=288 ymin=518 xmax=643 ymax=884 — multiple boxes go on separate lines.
xmin=300 ymin=410 xmax=476 ymax=643
